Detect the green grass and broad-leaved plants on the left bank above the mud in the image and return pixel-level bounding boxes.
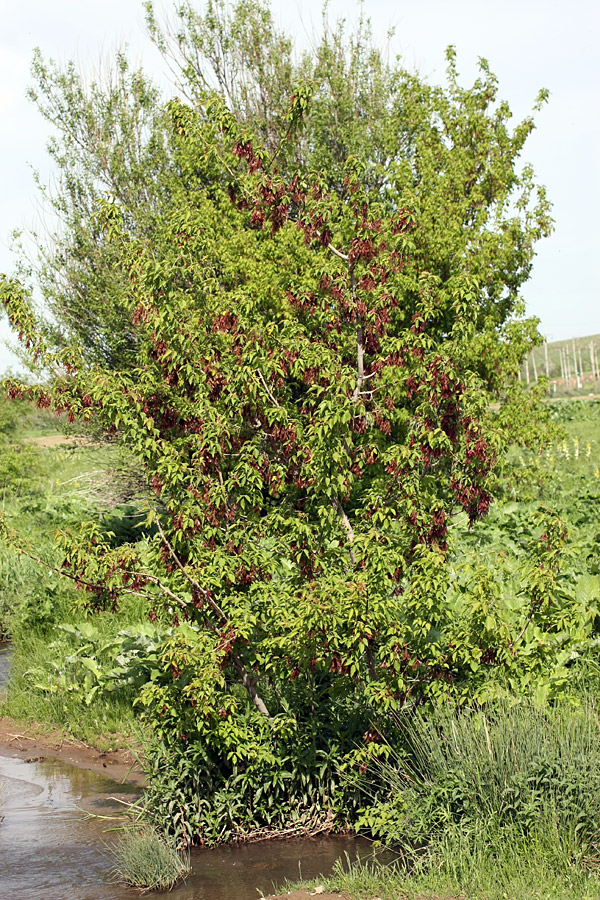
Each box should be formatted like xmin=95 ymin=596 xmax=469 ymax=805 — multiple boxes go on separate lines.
xmin=0 ymin=402 xmax=156 ymax=746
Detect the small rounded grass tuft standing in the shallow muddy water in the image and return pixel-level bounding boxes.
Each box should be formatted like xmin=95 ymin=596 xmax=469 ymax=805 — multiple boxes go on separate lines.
xmin=110 ymin=828 xmax=190 ymax=891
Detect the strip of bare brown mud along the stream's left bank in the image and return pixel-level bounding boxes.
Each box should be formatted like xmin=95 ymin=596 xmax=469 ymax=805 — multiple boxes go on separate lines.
xmin=0 ymin=717 xmax=144 ymax=786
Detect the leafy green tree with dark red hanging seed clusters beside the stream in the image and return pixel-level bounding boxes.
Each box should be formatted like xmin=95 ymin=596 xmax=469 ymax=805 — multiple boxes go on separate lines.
xmin=2 ymin=81 xmax=580 ymax=840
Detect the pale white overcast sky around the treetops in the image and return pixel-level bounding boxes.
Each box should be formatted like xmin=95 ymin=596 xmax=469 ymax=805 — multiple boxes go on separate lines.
xmin=0 ymin=0 xmax=600 ymax=370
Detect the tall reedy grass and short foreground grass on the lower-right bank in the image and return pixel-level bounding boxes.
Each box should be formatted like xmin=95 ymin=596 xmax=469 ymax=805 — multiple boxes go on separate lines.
xmin=330 ymin=700 xmax=600 ymax=900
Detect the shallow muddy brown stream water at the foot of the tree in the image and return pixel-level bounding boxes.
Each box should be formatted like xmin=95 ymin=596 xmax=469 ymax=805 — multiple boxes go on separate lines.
xmin=0 ymin=756 xmax=384 ymax=900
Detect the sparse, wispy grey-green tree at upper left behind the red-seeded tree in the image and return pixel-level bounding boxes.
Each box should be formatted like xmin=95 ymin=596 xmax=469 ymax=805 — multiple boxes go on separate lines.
xmin=13 ymin=50 xmax=170 ymax=369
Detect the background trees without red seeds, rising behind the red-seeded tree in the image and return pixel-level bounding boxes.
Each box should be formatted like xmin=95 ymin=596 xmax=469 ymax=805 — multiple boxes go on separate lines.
xmin=17 ymin=0 xmax=551 ymax=393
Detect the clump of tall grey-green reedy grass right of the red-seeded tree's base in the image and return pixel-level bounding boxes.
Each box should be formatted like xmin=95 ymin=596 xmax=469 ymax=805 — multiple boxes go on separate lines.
xmin=363 ymin=702 xmax=600 ymax=865
